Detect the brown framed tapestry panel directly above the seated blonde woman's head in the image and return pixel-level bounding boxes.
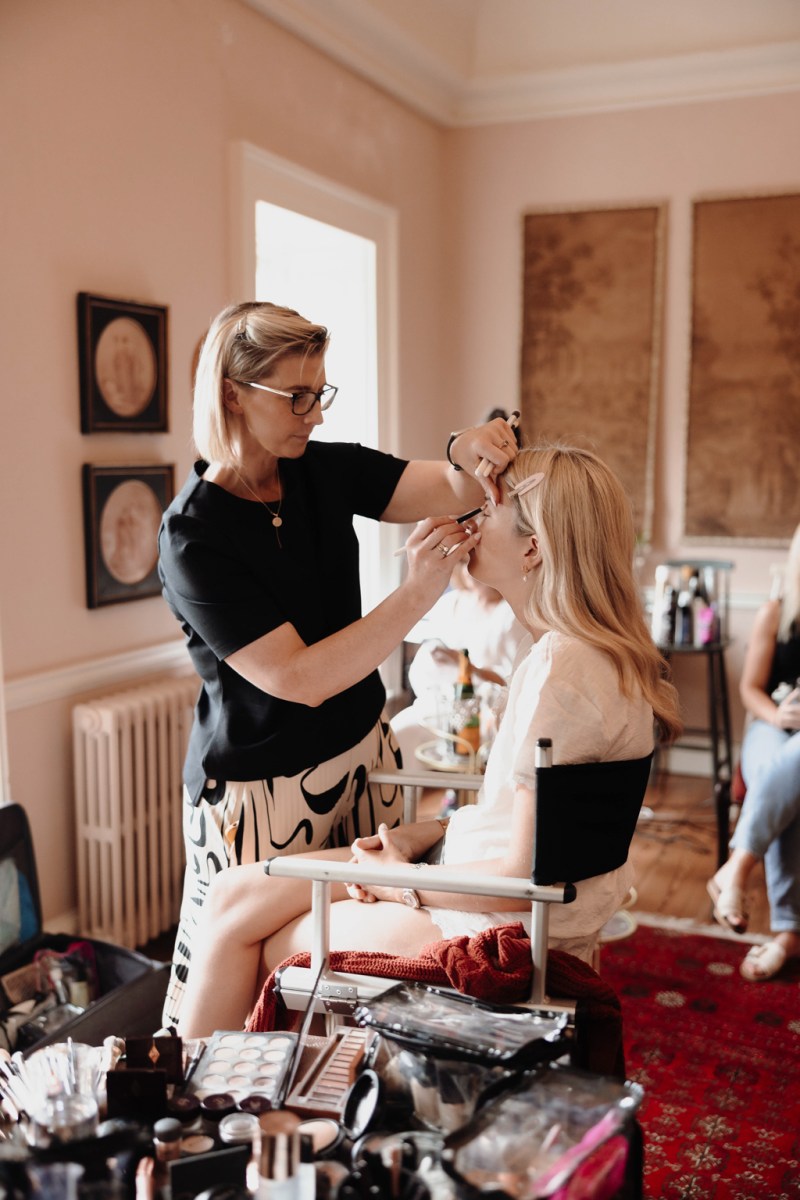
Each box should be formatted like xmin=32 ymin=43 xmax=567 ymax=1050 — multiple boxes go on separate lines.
xmin=521 ymin=203 xmax=667 ymax=542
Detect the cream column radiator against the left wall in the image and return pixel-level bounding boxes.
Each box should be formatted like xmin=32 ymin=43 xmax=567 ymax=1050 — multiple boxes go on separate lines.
xmin=72 ymin=676 xmax=199 ymax=948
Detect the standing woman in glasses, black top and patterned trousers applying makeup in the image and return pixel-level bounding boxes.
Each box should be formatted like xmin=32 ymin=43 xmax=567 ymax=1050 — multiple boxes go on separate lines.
xmin=158 ymin=302 xmax=517 ymax=1025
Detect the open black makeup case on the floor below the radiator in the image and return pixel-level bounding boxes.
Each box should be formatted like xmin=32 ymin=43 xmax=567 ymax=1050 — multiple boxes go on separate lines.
xmin=0 ymin=804 xmax=169 ymax=1052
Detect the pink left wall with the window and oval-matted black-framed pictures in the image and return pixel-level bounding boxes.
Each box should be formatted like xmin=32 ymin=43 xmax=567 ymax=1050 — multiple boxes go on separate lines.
xmin=0 ymin=0 xmax=455 ymax=916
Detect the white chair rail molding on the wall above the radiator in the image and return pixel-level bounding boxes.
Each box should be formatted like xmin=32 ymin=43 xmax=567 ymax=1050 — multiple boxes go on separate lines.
xmin=5 ymin=642 xmax=192 ymax=713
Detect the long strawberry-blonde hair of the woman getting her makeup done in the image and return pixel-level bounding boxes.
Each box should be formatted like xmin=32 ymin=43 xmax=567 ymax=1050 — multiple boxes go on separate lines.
xmin=504 ymin=445 xmax=681 ymax=742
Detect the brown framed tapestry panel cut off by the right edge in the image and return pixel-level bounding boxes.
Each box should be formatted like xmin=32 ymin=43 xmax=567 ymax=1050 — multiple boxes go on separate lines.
xmin=684 ymin=193 xmax=800 ymax=546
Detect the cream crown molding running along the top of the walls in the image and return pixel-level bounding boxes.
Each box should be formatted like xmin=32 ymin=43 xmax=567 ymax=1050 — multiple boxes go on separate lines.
xmin=246 ymin=0 xmax=800 ymax=126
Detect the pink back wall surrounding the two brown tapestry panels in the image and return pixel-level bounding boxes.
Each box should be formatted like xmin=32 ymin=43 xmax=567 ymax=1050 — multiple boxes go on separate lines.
xmin=446 ymin=92 xmax=800 ymax=737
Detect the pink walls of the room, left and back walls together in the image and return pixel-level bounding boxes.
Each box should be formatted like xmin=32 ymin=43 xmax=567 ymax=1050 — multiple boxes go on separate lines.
xmin=0 ymin=0 xmax=800 ymax=917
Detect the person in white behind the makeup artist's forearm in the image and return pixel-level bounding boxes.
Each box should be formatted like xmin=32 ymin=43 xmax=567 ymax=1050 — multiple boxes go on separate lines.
xmin=391 ymin=560 xmax=525 ymax=767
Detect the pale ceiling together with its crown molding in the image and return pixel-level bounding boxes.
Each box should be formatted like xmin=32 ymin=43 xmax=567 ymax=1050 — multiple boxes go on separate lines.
xmin=246 ymin=0 xmax=800 ymax=126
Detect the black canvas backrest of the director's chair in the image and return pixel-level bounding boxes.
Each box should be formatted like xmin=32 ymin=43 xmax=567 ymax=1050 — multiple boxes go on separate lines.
xmin=533 ymin=753 xmax=652 ymax=887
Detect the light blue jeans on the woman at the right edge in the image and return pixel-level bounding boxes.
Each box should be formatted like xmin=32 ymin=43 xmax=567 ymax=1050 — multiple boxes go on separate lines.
xmin=730 ymin=720 xmax=800 ymax=934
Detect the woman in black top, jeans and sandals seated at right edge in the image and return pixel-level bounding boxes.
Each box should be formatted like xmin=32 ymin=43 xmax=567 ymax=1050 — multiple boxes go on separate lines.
xmin=708 ymin=526 xmax=800 ymax=983
